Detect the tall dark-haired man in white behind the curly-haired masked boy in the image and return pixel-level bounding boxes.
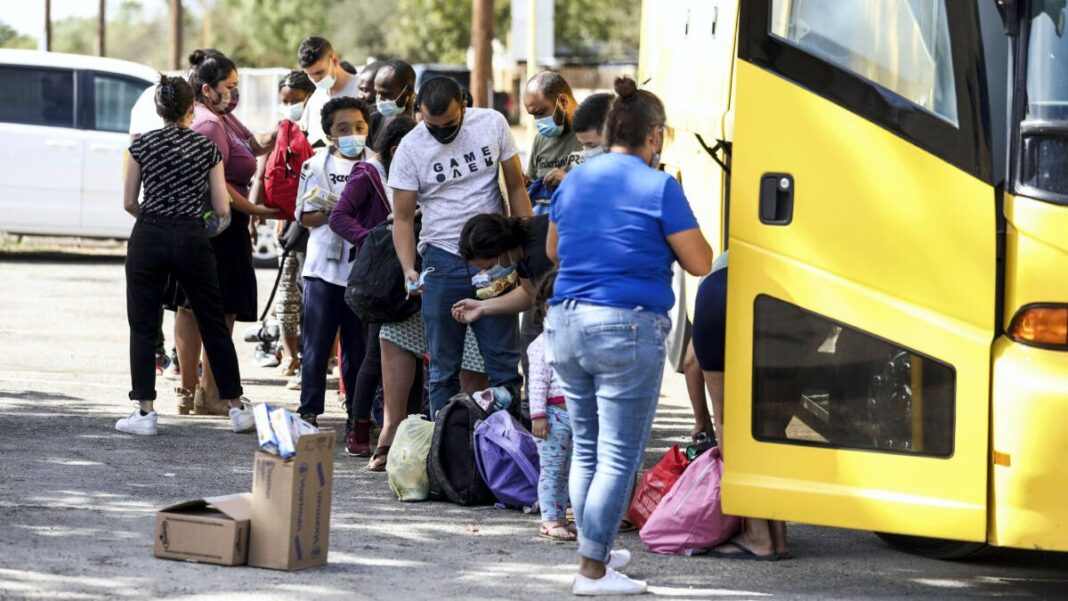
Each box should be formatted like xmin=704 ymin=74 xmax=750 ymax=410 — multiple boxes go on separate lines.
xmin=297 ymin=37 xmax=361 ymax=148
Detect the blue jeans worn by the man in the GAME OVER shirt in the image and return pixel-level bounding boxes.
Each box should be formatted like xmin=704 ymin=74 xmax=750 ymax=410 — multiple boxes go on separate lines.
xmin=423 ymin=246 xmax=522 ymax=417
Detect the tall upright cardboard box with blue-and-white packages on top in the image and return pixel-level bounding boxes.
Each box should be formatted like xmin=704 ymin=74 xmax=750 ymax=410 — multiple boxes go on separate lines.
xmin=249 ymin=430 xmax=334 ymax=570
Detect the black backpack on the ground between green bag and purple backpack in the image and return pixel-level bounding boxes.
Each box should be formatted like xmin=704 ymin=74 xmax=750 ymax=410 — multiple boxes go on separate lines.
xmin=426 ymin=393 xmax=497 ymax=505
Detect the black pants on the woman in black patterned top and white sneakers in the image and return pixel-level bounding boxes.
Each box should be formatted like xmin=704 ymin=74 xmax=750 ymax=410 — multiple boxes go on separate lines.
xmin=126 ymin=217 xmax=241 ymax=400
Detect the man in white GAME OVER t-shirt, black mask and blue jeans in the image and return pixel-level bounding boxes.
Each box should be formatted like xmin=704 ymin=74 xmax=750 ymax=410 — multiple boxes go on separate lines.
xmin=389 ymin=77 xmax=531 ymax=413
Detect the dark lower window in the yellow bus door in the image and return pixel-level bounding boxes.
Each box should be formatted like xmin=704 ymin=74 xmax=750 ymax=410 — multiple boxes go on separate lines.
xmin=753 ymin=296 xmax=955 ymax=457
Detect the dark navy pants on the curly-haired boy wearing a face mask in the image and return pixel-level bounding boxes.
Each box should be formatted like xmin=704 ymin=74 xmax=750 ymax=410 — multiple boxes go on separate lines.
xmin=298 ymin=278 xmax=365 ymax=415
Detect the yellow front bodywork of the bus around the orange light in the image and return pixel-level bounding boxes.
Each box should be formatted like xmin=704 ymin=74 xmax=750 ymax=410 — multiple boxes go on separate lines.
xmin=989 ymin=196 xmax=1068 ymax=551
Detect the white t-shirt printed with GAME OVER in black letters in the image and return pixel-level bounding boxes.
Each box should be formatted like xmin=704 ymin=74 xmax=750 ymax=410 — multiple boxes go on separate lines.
xmin=389 ymin=109 xmax=519 ymax=254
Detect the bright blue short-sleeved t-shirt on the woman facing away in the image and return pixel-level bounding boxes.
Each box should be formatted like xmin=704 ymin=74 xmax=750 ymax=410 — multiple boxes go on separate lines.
xmin=550 ymin=153 xmax=697 ymax=314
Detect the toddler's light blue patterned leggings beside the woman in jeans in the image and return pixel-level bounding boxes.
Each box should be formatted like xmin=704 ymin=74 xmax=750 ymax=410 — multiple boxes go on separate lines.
xmin=537 ymin=405 xmax=574 ymax=522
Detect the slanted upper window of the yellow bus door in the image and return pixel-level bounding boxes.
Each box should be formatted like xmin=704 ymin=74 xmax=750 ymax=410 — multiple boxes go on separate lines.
xmin=771 ymin=0 xmax=958 ymax=125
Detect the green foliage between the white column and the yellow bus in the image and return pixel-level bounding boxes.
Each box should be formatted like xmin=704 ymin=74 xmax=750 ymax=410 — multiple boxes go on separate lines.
xmin=553 ymin=0 xmax=642 ymax=61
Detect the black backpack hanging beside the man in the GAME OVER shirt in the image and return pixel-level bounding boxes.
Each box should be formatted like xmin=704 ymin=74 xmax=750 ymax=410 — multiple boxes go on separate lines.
xmin=345 ymin=217 xmax=422 ymax=323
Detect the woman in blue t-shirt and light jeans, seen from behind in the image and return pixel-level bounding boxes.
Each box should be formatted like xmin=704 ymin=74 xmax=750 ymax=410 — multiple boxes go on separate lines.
xmin=546 ymin=78 xmax=712 ymax=595
